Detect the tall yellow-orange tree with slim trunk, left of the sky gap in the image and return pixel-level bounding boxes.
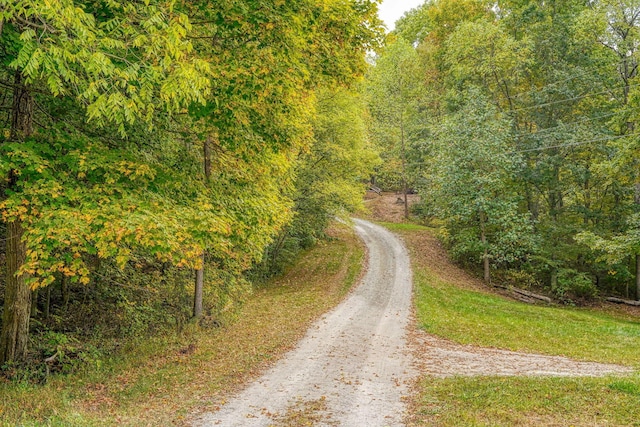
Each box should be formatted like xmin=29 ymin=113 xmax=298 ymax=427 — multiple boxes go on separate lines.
xmin=185 ymin=0 xmax=380 ymax=315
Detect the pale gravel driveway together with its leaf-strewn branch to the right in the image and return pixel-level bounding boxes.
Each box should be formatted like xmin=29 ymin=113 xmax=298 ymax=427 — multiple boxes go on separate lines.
xmin=194 ymin=214 xmax=633 ymax=427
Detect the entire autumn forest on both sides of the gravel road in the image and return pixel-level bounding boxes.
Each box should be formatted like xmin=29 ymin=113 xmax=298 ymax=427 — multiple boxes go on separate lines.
xmin=0 ymin=0 xmax=640 ymax=394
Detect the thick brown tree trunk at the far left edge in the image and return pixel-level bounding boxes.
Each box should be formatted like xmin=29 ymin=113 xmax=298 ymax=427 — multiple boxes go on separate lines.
xmin=0 ymin=221 xmax=31 ymax=365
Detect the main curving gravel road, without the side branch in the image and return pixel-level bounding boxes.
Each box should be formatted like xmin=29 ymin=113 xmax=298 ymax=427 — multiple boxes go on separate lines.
xmin=194 ymin=220 xmax=412 ymax=427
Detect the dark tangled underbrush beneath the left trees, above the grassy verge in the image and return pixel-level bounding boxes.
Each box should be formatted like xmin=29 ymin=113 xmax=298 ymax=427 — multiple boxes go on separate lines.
xmin=0 ymin=261 xmax=251 ymax=384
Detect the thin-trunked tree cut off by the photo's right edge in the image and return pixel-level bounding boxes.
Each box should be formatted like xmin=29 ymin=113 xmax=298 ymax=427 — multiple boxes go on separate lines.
xmin=579 ymin=0 xmax=640 ymax=300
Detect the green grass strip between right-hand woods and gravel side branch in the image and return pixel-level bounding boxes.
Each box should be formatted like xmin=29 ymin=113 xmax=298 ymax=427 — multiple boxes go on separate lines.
xmin=414 ymin=270 xmax=640 ymax=368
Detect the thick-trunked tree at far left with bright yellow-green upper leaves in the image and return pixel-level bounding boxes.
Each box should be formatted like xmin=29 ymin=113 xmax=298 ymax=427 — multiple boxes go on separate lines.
xmin=0 ymin=0 xmax=208 ymax=365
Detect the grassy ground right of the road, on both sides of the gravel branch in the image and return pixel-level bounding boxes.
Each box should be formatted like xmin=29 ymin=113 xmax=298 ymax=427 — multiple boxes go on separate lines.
xmin=385 ymin=224 xmax=640 ymax=426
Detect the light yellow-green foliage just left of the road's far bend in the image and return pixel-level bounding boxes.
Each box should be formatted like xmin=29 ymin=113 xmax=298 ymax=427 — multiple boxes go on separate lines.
xmin=254 ymin=89 xmax=379 ymax=276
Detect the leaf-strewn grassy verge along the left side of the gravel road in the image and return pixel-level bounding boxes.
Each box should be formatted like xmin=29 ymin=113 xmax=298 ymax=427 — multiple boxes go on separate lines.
xmin=0 ymin=225 xmax=364 ymax=426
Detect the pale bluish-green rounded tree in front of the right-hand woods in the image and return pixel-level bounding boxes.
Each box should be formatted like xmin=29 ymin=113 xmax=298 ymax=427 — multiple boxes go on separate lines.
xmin=423 ymin=89 xmax=534 ymax=282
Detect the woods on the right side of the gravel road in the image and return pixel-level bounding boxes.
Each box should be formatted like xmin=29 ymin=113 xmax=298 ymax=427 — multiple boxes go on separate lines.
xmin=366 ymin=0 xmax=640 ymax=304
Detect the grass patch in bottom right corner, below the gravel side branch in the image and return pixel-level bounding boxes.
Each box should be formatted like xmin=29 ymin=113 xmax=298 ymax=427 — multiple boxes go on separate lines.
xmin=413 ymin=377 xmax=640 ymax=427
